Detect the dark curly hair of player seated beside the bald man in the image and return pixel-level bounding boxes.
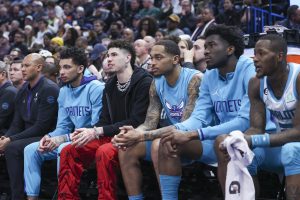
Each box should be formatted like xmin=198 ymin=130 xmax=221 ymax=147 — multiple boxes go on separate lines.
xmin=60 ymin=47 xmax=88 ymax=69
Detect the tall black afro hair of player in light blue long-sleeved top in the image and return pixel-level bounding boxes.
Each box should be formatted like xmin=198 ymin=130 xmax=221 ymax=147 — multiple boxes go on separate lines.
xmin=205 ymin=24 xmax=245 ymax=58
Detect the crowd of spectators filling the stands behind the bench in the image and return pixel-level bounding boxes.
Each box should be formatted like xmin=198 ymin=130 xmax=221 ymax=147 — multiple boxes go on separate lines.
xmin=0 ymin=0 xmax=300 ymax=78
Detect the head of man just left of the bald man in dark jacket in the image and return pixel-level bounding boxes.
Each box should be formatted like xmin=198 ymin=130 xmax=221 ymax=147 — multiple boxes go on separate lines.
xmin=9 ymin=60 xmax=25 ymax=90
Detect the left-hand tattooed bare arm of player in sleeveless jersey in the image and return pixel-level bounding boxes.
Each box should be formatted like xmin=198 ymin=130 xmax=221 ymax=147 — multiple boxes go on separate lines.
xmin=137 ymin=80 xmax=162 ymax=131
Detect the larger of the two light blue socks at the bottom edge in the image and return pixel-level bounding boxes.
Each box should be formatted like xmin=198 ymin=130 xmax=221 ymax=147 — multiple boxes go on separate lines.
xmin=159 ymin=175 xmax=181 ymax=200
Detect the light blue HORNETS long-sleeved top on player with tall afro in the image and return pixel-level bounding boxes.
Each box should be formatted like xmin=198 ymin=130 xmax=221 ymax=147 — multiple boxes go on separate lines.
xmin=175 ymin=56 xmax=255 ymax=140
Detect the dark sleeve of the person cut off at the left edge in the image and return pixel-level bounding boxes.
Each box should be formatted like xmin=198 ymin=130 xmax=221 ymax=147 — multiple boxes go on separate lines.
xmin=0 ymin=90 xmax=16 ymax=129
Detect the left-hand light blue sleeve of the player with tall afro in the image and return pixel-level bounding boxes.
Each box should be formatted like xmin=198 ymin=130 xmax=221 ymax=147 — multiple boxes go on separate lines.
xmin=175 ymin=75 xmax=213 ymax=131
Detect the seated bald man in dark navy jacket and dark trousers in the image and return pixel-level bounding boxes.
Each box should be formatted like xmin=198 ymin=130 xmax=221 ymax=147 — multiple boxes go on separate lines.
xmin=0 ymin=53 xmax=59 ymax=200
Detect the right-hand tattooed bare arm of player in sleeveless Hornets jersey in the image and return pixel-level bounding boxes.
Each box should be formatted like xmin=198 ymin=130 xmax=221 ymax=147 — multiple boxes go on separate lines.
xmin=181 ymin=73 xmax=203 ymax=121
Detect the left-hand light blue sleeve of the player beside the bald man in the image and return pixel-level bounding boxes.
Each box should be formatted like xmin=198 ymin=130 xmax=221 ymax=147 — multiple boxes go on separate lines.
xmin=48 ymin=89 xmax=74 ymax=137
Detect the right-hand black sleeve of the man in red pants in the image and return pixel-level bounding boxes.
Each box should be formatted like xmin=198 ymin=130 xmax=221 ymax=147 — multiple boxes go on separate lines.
xmin=103 ymin=77 xmax=152 ymax=136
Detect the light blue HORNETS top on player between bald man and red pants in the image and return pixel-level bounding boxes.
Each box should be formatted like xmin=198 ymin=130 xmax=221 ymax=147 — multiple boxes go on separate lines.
xmin=49 ymin=76 xmax=104 ymax=137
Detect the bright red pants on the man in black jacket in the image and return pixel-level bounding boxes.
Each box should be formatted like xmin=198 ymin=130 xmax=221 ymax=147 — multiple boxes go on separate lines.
xmin=58 ymin=137 xmax=119 ymax=200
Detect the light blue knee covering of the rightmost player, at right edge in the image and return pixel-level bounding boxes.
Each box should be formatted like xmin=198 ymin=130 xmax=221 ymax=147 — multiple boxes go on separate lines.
xmin=281 ymin=142 xmax=300 ymax=175
